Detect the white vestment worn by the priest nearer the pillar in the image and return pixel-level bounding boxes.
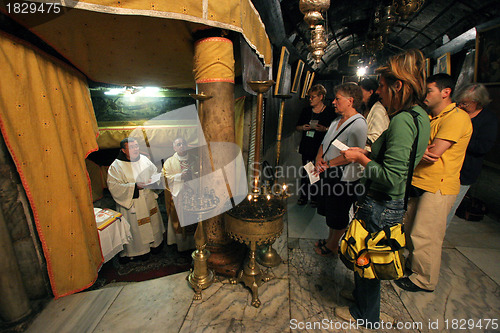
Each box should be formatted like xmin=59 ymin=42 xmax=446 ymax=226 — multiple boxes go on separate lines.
xmin=163 ymin=153 xmax=198 ymax=251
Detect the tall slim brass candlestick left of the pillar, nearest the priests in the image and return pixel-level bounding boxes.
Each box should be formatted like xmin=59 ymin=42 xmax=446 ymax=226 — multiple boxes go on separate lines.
xmin=187 ymin=93 xmax=214 ymax=300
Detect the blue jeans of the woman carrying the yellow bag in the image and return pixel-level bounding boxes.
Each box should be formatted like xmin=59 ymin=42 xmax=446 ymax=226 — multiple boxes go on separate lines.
xmin=349 ymin=197 xmax=405 ymax=323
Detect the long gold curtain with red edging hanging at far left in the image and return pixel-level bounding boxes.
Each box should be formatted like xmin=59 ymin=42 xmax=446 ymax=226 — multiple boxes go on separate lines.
xmin=0 ymin=33 xmax=103 ymax=298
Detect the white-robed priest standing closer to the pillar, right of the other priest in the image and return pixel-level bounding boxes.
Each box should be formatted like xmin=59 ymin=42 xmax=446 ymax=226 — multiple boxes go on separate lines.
xmin=163 ymin=138 xmax=199 ymax=251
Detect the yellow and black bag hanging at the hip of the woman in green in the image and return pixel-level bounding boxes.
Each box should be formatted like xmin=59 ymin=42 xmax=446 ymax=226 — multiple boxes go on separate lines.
xmin=340 ymin=218 xmax=405 ymax=280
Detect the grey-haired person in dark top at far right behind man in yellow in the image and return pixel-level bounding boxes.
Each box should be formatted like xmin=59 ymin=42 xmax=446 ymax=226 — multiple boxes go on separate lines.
xmin=446 ymin=83 xmax=498 ymax=227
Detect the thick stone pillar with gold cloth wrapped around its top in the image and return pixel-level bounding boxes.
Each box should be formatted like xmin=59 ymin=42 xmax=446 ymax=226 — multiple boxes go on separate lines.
xmin=193 ymin=30 xmax=242 ymax=276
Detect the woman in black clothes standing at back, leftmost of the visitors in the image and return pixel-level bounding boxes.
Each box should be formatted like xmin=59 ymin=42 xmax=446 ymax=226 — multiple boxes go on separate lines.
xmin=297 ymin=84 xmax=335 ymax=207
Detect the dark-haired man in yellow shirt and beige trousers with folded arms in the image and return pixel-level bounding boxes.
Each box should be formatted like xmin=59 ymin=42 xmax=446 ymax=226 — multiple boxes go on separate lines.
xmin=395 ymin=73 xmax=472 ymax=292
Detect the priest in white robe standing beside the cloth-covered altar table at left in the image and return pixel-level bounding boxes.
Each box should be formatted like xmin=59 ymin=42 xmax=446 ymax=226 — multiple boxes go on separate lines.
xmin=107 ymin=138 xmax=165 ymax=257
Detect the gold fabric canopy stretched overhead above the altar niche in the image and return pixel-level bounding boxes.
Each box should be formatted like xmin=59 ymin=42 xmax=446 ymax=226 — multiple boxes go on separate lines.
xmin=0 ymin=0 xmax=272 ymax=88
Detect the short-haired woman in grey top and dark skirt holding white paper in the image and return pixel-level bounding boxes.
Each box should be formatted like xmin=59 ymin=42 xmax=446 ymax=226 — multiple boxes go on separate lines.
xmin=314 ymin=83 xmax=367 ymax=256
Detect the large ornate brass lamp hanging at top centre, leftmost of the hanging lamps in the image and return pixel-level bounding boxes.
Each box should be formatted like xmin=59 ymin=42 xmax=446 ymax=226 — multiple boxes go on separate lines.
xmin=299 ymin=0 xmax=330 ymax=63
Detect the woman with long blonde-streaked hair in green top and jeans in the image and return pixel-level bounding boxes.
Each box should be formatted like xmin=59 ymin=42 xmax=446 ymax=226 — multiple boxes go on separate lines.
xmin=335 ymin=50 xmax=430 ymax=326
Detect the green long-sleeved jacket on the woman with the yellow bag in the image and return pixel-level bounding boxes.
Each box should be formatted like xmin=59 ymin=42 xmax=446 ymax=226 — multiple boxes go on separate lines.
xmin=364 ymin=106 xmax=430 ymax=200
